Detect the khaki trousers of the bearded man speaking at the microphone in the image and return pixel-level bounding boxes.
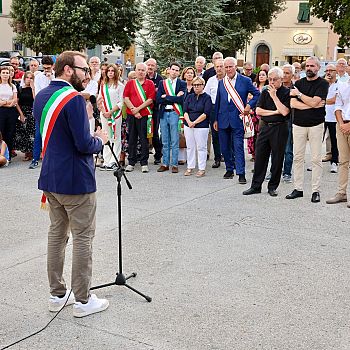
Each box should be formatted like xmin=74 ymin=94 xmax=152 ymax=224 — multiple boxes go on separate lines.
xmin=44 ymin=192 xmax=96 ymax=303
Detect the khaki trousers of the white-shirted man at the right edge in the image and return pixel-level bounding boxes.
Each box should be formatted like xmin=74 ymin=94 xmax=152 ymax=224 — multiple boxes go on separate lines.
xmin=337 ymin=124 xmax=350 ymax=194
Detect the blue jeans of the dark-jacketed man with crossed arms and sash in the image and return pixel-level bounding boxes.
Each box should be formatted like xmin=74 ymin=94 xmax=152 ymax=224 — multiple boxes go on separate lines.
xmin=160 ymin=111 xmax=179 ymax=166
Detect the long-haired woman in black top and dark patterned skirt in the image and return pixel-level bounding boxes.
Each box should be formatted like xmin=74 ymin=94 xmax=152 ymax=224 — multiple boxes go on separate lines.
xmin=16 ymin=71 xmax=35 ymax=161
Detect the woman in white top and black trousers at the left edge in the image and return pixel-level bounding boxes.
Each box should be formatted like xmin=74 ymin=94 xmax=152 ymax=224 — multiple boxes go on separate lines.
xmin=0 ymin=66 xmax=18 ymax=161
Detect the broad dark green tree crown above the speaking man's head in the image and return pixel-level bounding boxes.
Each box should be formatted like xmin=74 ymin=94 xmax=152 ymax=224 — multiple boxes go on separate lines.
xmin=11 ymin=0 xmax=140 ymax=53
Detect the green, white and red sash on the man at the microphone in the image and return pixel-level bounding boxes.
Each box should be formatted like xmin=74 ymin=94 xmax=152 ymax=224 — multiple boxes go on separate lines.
xmin=40 ymin=86 xmax=79 ymax=209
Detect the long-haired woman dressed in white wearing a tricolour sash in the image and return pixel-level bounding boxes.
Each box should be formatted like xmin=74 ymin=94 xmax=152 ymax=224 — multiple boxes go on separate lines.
xmin=98 ymin=64 xmax=124 ymax=171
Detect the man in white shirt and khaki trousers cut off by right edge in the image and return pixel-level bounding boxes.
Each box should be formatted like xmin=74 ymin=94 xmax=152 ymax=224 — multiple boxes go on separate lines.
xmin=326 ymin=74 xmax=350 ymax=208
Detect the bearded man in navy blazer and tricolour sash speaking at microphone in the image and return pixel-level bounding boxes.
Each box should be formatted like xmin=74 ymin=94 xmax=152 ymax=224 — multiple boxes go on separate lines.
xmin=33 ymin=51 xmax=109 ymax=317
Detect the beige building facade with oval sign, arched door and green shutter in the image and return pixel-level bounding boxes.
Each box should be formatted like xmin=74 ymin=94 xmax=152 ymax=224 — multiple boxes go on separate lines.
xmin=238 ymin=0 xmax=345 ymax=67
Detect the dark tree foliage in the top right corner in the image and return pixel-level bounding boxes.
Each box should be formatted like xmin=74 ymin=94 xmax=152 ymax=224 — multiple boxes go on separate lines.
xmin=309 ymin=0 xmax=350 ymax=47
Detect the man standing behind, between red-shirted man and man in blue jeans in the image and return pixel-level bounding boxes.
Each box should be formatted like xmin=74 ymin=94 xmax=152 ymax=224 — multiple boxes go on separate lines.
xmin=145 ymin=58 xmax=163 ymax=165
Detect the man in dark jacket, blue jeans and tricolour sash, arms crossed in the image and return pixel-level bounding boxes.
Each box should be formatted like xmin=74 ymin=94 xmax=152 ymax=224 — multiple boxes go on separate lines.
xmin=156 ymin=62 xmax=186 ymax=173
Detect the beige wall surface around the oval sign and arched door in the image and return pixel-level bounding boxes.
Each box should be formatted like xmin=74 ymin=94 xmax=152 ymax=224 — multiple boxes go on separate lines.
xmin=238 ymin=0 xmax=338 ymax=65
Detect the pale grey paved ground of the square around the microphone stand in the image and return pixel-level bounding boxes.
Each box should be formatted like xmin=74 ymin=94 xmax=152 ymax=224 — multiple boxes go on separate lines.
xmin=0 ymin=148 xmax=350 ymax=350
